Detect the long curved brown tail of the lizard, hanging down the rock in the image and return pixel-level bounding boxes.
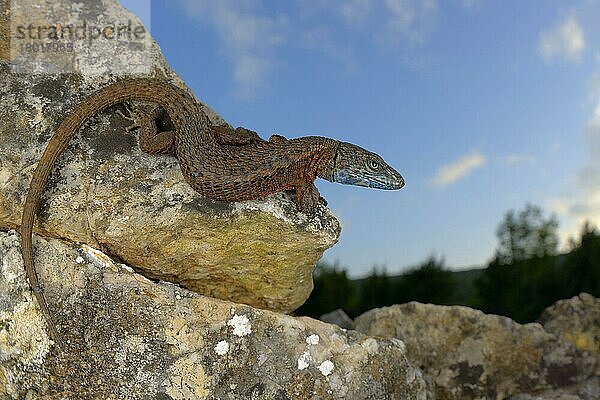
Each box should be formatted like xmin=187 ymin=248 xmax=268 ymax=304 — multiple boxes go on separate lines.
xmin=21 ymin=79 xmax=188 ymax=344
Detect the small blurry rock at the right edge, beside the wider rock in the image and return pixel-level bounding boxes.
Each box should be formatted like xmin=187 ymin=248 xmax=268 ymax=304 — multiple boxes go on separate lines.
xmin=538 ymin=293 xmax=600 ymax=358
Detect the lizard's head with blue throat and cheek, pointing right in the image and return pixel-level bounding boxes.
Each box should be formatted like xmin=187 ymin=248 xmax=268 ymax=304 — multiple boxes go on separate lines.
xmin=322 ymin=142 xmax=404 ymax=190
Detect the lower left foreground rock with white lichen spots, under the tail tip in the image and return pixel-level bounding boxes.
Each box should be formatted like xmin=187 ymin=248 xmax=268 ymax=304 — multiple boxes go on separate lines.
xmin=0 ymin=232 xmax=425 ymax=400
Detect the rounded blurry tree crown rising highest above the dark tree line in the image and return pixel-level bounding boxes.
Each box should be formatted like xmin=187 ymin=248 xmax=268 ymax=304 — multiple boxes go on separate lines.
xmin=496 ymin=204 xmax=558 ymax=265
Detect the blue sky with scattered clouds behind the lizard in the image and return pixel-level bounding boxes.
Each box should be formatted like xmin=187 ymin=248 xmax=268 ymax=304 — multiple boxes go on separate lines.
xmin=122 ymin=0 xmax=600 ymax=277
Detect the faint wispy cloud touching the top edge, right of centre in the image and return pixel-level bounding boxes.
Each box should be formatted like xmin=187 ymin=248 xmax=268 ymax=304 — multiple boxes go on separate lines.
xmin=385 ymin=0 xmax=438 ymax=44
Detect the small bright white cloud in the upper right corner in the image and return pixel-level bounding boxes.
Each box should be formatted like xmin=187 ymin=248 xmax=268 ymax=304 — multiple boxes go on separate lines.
xmin=539 ymin=15 xmax=585 ymax=61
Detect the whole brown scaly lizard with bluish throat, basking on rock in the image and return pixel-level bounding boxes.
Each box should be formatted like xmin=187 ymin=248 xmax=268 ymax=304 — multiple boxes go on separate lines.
xmin=21 ymin=78 xmax=404 ymax=344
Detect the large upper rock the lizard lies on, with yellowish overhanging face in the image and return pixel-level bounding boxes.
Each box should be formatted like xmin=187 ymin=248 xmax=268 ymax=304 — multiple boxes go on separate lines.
xmin=0 ymin=0 xmax=340 ymax=312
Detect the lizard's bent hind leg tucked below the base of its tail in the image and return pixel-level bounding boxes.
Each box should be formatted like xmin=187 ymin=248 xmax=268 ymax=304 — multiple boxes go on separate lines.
xmin=131 ymin=106 xmax=175 ymax=155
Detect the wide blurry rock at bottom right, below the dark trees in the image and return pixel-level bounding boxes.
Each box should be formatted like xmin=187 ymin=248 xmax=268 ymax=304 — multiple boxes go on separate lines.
xmin=355 ymin=302 xmax=596 ymax=399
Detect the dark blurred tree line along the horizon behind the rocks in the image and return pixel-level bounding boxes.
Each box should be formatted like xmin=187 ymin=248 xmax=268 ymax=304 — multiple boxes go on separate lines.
xmin=297 ymin=205 xmax=600 ymax=322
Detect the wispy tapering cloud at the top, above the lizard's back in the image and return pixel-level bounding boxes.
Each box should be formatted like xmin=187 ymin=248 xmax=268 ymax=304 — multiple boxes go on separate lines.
xmin=180 ymin=0 xmax=287 ymax=98
